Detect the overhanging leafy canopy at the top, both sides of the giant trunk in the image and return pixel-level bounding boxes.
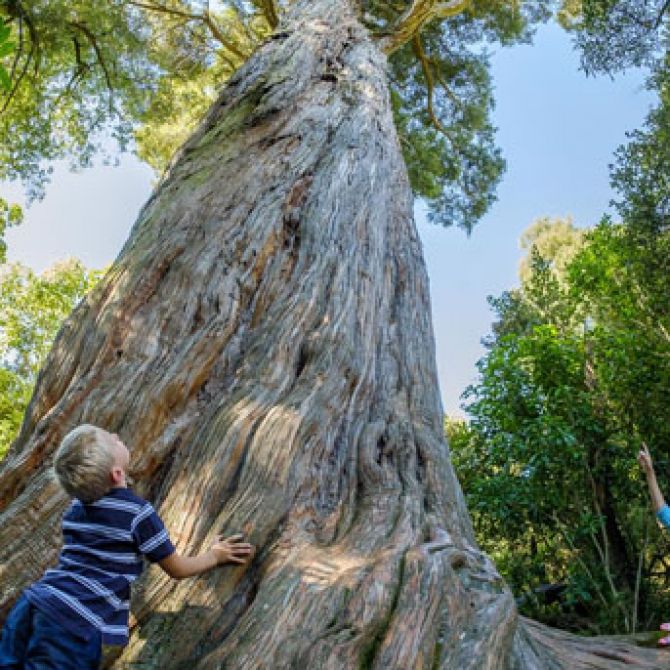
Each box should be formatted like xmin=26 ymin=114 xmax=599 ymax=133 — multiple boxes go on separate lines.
xmin=0 ymin=0 xmax=552 ymax=230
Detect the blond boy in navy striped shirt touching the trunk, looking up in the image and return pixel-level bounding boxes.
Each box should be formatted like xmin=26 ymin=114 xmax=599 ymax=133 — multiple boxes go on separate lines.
xmin=0 ymin=424 xmax=253 ymax=670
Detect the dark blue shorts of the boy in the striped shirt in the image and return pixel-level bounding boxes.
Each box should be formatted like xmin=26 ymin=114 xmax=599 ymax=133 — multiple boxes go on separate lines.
xmin=0 ymin=595 xmax=102 ymax=670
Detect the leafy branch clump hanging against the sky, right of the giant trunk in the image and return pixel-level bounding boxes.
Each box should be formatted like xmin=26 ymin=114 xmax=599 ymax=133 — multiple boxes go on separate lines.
xmin=390 ymin=2 xmax=549 ymax=232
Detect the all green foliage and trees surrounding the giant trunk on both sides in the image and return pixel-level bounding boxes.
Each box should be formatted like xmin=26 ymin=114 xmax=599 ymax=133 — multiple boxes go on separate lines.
xmin=0 ymin=0 xmax=670 ymax=633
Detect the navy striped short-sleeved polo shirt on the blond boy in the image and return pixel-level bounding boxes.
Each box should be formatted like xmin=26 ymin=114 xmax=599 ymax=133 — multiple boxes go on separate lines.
xmin=26 ymin=488 xmax=175 ymax=645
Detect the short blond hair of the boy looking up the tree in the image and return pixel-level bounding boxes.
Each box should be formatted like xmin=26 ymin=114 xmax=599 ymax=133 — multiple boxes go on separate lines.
xmin=54 ymin=423 xmax=114 ymax=503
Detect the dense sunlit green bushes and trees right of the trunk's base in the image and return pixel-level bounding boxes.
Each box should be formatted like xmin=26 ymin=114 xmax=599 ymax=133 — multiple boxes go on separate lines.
xmin=447 ymin=220 xmax=670 ymax=633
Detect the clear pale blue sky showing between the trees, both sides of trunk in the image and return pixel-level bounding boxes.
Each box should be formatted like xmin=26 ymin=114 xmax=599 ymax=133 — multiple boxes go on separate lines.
xmin=2 ymin=21 xmax=653 ymax=415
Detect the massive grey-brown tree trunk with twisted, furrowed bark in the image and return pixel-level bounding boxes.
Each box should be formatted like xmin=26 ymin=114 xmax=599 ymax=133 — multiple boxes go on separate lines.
xmin=0 ymin=0 xmax=665 ymax=670
